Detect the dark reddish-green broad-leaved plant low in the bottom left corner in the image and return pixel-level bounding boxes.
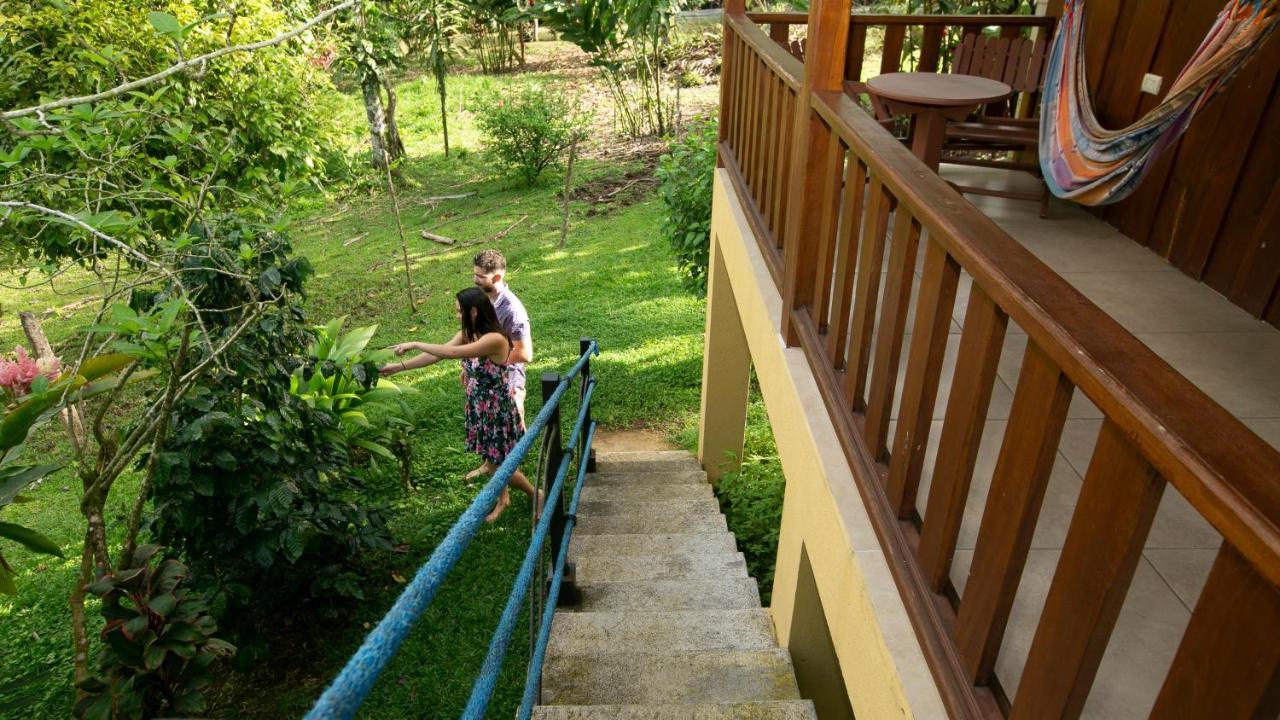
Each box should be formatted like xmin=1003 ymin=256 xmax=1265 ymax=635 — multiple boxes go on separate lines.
xmin=76 ymin=544 xmax=236 ymax=720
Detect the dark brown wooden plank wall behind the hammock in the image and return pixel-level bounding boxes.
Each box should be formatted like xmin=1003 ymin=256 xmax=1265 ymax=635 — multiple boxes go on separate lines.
xmin=1064 ymin=0 xmax=1280 ymax=327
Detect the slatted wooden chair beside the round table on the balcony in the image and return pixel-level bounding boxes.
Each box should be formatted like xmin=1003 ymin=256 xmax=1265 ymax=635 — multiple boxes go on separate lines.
xmin=942 ymin=32 xmax=1052 ymax=218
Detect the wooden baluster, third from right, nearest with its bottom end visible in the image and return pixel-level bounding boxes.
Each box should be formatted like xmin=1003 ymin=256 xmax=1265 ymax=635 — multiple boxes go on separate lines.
xmin=956 ymin=340 xmax=1074 ymax=685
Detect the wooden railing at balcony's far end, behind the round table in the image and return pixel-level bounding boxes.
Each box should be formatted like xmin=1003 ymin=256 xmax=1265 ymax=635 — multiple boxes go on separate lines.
xmin=748 ymin=13 xmax=1055 ymax=111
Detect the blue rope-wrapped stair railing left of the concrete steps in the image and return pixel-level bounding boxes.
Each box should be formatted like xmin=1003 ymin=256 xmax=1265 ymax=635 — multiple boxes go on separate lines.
xmin=306 ymin=341 xmax=600 ymax=720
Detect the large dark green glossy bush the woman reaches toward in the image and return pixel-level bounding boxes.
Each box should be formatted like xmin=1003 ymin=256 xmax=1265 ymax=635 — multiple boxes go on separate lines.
xmin=140 ymin=220 xmax=396 ymax=665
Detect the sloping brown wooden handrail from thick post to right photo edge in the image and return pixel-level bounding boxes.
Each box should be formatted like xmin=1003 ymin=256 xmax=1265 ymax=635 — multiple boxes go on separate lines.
xmin=813 ymin=92 xmax=1280 ymax=587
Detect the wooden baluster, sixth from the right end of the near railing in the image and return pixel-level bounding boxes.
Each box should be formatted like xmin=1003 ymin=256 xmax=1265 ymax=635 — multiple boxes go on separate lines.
xmin=865 ymin=202 xmax=920 ymax=460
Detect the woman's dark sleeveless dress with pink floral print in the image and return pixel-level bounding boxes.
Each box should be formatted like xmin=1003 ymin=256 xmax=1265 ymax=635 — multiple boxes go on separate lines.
xmin=462 ymin=357 xmax=525 ymax=465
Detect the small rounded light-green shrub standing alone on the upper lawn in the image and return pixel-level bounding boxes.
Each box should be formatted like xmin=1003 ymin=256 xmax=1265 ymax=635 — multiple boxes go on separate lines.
xmin=477 ymin=87 xmax=582 ymax=184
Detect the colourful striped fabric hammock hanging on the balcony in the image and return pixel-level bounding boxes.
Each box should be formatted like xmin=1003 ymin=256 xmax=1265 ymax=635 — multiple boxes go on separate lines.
xmin=1039 ymin=0 xmax=1280 ymax=205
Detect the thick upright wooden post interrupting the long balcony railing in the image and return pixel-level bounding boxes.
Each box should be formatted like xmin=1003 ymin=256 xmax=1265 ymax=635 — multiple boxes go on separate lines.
xmin=781 ymin=0 xmax=850 ymax=347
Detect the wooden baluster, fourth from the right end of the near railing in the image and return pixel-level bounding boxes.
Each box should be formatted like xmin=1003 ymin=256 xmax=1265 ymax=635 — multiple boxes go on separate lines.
xmin=919 ymin=284 xmax=1009 ymax=592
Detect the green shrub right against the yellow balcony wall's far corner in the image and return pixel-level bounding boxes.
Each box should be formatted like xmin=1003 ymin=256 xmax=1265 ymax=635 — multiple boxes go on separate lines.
xmin=658 ymin=119 xmax=717 ymax=295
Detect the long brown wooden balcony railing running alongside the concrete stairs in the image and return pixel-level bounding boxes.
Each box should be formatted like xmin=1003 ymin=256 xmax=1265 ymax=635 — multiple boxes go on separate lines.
xmin=719 ymin=12 xmax=1280 ymax=719
